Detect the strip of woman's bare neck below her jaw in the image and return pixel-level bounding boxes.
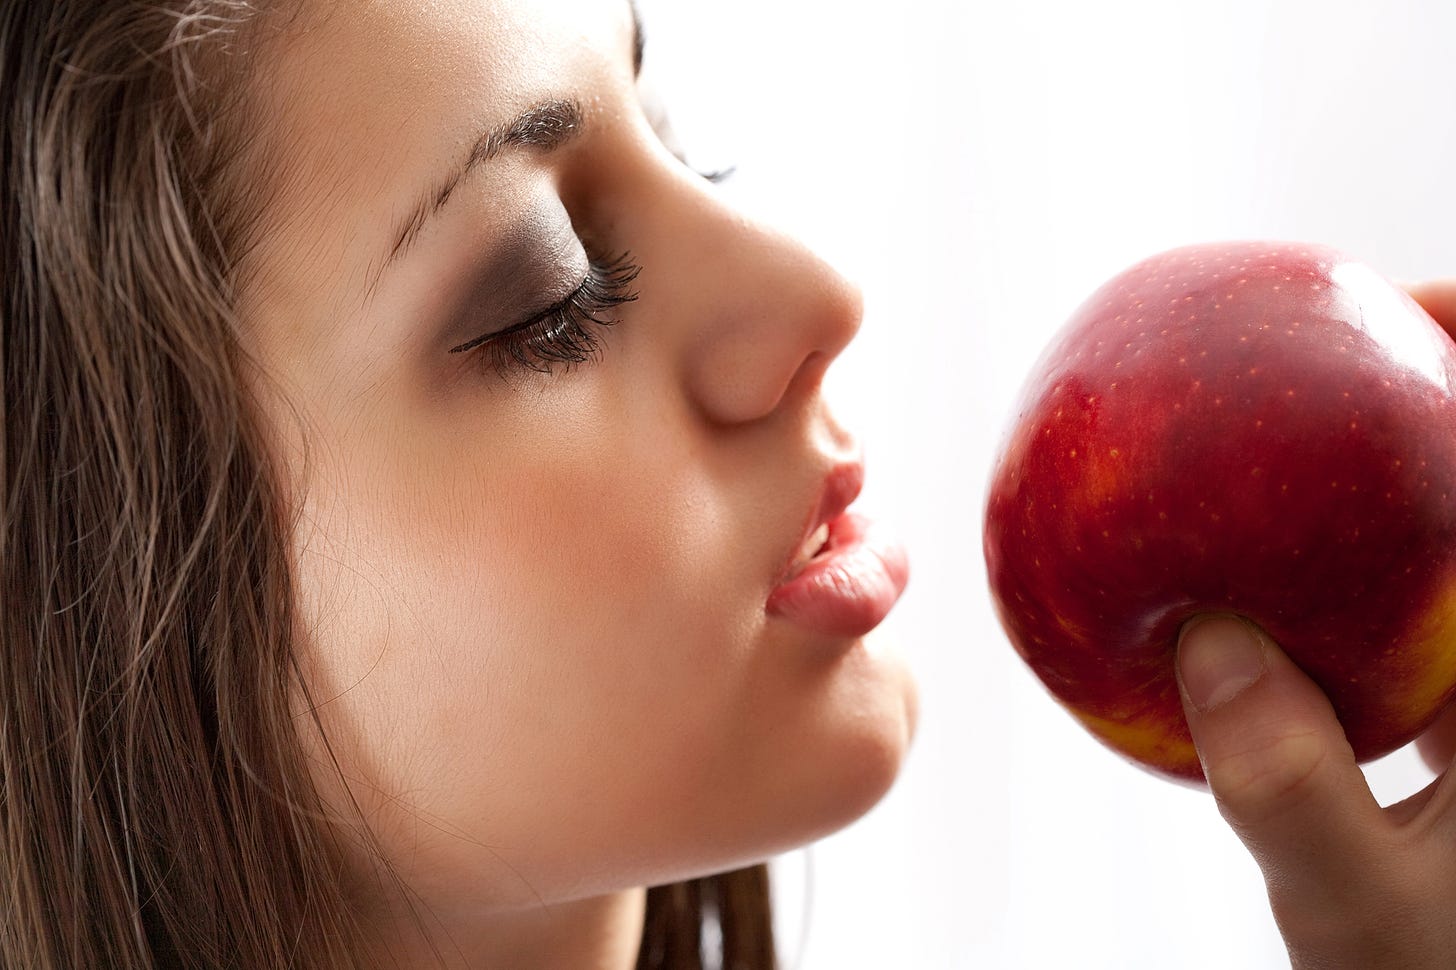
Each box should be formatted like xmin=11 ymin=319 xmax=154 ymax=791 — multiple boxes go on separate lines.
xmin=369 ymin=888 xmax=646 ymax=970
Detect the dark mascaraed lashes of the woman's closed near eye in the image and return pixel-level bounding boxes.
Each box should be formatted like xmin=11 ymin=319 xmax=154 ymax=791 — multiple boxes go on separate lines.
xmin=450 ymin=252 xmax=642 ymax=376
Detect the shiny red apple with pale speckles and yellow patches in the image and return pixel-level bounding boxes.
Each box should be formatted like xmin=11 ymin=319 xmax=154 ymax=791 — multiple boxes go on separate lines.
xmin=983 ymin=242 xmax=1456 ymax=784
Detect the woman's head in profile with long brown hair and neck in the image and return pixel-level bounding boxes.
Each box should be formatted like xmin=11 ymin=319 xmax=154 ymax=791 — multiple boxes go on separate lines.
xmin=0 ymin=0 xmax=914 ymax=967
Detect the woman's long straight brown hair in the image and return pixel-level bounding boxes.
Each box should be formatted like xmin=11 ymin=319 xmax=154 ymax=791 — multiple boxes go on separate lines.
xmin=0 ymin=0 xmax=773 ymax=970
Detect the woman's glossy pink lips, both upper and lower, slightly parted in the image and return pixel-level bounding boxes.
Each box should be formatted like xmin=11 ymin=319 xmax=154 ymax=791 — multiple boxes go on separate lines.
xmin=766 ymin=462 xmax=910 ymax=638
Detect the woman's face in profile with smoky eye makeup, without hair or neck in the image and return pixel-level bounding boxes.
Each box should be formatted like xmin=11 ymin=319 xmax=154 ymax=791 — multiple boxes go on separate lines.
xmin=243 ymin=0 xmax=914 ymax=912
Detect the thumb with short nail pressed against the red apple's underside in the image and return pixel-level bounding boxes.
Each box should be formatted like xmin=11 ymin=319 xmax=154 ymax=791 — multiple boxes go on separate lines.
xmin=1178 ymin=616 xmax=1386 ymax=885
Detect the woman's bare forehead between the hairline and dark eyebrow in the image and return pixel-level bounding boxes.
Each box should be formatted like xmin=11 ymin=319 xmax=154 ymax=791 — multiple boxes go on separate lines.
xmin=237 ymin=0 xmax=633 ymax=317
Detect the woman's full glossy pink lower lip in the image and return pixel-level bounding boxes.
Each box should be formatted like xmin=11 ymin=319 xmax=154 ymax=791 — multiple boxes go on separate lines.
xmin=767 ymin=513 xmax=910 ymax=638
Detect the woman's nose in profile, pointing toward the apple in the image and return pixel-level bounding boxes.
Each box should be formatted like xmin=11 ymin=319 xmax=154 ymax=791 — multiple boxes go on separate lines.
xmin=661 ymin=195 xmax=863 ymax=424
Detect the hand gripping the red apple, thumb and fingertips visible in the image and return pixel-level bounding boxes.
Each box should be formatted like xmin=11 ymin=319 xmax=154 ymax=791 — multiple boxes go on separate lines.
xmin=1178 ymin=281 xmax=1456 ymax=970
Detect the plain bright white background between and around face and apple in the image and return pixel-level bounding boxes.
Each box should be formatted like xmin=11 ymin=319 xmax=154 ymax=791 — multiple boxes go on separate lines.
xmin=641 ymin=0 xmax=1456 ymax=970
